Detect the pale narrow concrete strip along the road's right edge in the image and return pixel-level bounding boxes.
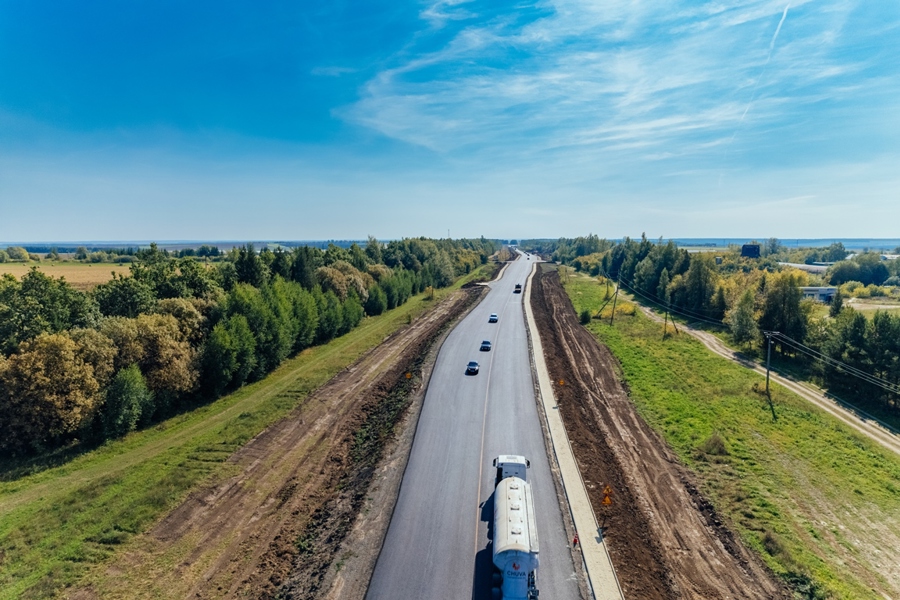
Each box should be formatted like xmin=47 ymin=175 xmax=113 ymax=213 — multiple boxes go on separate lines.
xmin=524 ymin=263 xmax=625 ymax=600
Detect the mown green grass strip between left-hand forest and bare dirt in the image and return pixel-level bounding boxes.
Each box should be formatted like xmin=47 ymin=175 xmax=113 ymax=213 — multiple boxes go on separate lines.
xmin=0 ymin=272 xmax=492 ymax=599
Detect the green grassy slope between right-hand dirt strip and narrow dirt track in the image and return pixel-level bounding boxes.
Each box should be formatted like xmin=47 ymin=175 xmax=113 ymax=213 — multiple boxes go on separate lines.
xmin=566 ymin=276 xmax=900 ymax=598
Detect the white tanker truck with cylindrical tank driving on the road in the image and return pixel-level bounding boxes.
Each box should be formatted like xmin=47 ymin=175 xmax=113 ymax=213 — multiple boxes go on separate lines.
xmin=491 ymin=455 xmax=539 ymax=600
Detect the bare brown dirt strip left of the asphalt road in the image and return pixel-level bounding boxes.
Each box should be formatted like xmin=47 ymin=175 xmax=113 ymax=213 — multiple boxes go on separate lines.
xmin=71 ymin=286 xmax=484 ymax=599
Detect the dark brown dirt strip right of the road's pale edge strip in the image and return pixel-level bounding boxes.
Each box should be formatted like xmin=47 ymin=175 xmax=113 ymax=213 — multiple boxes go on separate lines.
xmin=532 ymin=271 xmax=790 ymax=599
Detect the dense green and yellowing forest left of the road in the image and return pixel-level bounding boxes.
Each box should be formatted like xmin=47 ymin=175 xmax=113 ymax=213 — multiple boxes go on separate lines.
xmin=0 ymin=238 xmax=499 ymax=456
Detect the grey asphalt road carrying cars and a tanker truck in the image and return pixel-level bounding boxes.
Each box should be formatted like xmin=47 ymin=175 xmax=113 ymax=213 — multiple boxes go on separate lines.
xmin=366 ymin=256 xmax=580 ymax=600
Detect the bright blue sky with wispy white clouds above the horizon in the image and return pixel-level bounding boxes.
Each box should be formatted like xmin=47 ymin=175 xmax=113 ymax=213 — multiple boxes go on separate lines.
xmin=0 ymin=0 xmax=900 ymax=241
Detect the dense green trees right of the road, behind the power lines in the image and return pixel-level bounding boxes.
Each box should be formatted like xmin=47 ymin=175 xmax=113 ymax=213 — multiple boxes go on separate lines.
xmin=521 ymin=235 xmax=900 ymax=416
